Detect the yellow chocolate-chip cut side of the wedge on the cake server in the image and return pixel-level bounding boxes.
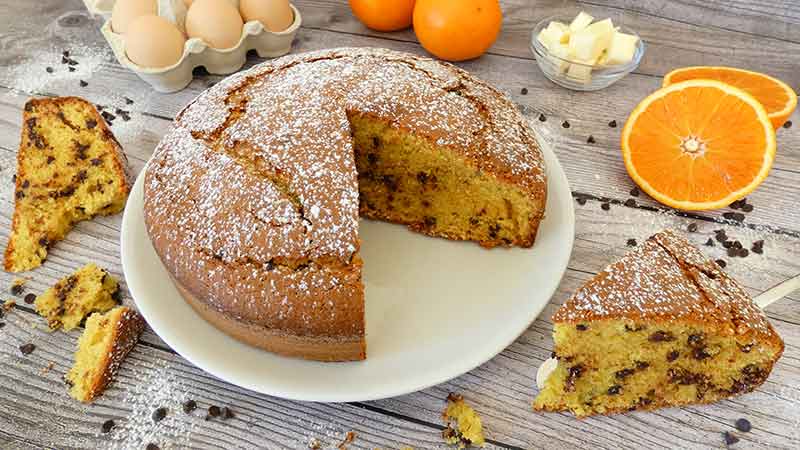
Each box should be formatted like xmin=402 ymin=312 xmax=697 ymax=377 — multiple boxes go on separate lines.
xmin=535 ymin=320 xmax=781 ymax=417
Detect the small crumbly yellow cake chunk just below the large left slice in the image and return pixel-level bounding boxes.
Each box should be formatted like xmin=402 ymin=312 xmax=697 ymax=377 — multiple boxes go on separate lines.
xmin=34 ymin=263 xmax=119 ymax=331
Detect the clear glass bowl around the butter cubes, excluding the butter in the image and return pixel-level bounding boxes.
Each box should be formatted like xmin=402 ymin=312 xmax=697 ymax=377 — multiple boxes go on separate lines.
xmin=531 ymin=16 xmax=645 ymax=91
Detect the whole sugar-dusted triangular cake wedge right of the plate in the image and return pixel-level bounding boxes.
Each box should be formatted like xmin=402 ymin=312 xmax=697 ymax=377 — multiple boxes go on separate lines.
xmin=534 ymin=230 xmax=783 ymax=417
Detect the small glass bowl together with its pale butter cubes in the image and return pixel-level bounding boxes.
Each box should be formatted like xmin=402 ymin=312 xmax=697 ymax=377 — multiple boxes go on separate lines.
xmin=531 ymin=11 xmax=645 ymax=91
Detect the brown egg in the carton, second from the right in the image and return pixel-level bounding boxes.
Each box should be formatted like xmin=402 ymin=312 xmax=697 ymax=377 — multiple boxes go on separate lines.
xmin=186 ymin=0 xmax=244 ymax=49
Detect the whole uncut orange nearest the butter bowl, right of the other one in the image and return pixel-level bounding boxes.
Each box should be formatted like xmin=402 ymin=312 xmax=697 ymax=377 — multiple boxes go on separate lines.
xmin=414 ymin=0 xmax=503 ymax=61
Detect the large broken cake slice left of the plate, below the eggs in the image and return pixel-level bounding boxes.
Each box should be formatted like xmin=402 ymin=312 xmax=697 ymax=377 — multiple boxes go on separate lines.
xmin=4 ymin=97 xmax=130 ymax=272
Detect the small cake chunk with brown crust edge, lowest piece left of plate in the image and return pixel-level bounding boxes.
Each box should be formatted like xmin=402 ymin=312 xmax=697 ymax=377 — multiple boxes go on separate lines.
xmin=65 ymin=306 xmax=145 ymax=402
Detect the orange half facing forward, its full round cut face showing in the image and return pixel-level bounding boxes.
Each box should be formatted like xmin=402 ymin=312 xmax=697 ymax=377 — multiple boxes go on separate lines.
xmin=622 ymin=79 xmax=775 ymax=210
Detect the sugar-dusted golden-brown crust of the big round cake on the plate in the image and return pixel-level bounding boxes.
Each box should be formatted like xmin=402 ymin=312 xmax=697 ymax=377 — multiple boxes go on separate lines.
xmin=144 ymin=48 xmax=546 ymax=359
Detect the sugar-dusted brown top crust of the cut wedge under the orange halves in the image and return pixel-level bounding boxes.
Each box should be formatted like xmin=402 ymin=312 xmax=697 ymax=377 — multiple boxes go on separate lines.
xmin=553 ymin=230 xmax=783 ymax=349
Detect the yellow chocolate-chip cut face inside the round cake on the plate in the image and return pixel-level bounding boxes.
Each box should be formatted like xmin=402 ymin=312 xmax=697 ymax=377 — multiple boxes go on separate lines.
xmin=349 ymin=113 xmax=540 ymax=247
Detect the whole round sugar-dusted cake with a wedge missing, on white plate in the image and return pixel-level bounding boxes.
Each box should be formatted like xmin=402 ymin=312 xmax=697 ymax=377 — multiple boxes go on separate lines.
xmin=144 ymin=48 xmax=546 ymax=361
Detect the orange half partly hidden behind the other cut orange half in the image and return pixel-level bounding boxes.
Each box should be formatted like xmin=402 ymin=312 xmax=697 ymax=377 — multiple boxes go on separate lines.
xmin=662 ymin=66 xmax=797 ymax=130
